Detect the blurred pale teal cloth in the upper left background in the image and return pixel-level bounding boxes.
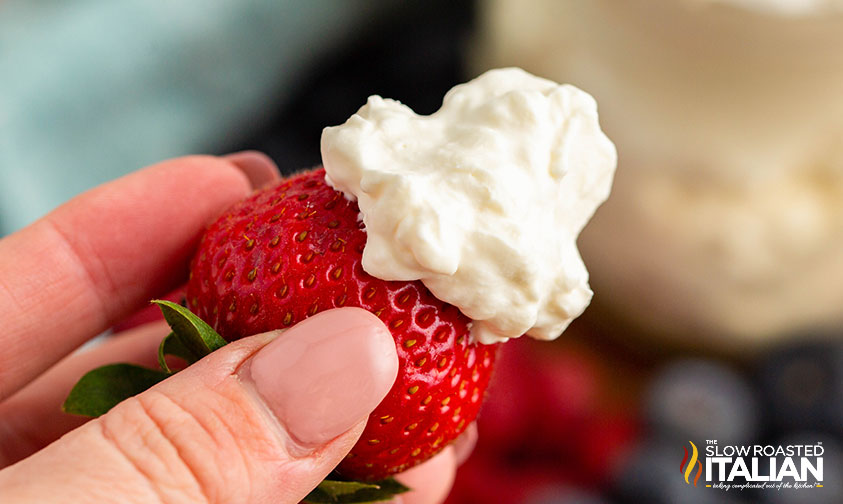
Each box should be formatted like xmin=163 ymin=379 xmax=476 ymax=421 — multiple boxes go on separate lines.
xmin=0 ymin=0 xmax=385 ymax=235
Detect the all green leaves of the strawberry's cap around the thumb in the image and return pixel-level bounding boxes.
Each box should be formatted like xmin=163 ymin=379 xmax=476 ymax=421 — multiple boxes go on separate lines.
xmin=62 ymin=300 xmax=409 ymax=504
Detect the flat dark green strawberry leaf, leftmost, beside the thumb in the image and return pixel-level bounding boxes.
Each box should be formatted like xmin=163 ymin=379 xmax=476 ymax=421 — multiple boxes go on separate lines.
xmin=62 ymin=364 xmax=170 ymax=417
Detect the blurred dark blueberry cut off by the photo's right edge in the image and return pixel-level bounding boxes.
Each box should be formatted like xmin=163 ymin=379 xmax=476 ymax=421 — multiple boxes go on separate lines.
xmin=758 ymin=340 xmax=843 ymax=436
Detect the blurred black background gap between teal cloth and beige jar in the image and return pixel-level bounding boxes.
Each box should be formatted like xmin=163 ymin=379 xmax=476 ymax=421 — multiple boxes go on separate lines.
xmin=227 ymin=1 xmax=475 ymax=173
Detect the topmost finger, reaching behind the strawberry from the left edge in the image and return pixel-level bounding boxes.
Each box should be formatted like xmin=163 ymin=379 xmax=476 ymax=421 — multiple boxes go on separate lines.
xmin=0 ymin=156 xmax=251 ymax=400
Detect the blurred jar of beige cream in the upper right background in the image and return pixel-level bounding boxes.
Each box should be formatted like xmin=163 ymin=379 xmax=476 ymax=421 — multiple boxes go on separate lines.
xmin=472 ymin=0 xmax=843 ymax=346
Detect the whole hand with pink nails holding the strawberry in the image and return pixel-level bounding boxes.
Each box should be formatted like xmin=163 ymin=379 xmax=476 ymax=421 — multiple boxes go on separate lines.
xmin=0 ymin=152 xmax=476 ymax=504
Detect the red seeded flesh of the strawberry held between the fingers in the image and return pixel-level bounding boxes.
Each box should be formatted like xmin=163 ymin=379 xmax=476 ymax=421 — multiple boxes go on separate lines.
xmin=187 ymin=169 xmax=496 ymax=480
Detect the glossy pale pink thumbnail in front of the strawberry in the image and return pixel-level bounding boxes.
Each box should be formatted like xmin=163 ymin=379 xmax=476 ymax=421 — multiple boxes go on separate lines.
xmin=248 ymin=308 xmax=398 ymax=447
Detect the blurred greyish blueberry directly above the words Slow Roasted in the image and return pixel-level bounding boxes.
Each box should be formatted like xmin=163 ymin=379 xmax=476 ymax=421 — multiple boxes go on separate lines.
xmin=644 ymin=359 xmax=759 ymax=443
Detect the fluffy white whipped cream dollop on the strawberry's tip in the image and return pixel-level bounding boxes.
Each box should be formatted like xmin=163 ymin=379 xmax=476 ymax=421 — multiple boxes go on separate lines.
xmin=322 ymin=68 xmax=617 ymax=344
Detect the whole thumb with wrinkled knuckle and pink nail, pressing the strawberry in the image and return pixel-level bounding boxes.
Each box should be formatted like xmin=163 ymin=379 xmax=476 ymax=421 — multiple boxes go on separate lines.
xmin=0 ymin=308 xmax=398 ymax=503
